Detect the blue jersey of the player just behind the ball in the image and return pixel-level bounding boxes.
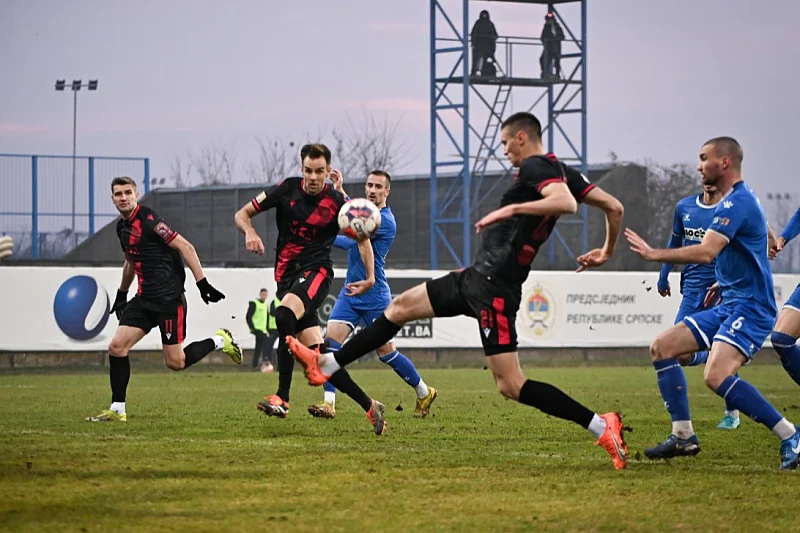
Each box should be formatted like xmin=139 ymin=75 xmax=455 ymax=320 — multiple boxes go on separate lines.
xmin=333 ymin=205 xmax=397 ymax=306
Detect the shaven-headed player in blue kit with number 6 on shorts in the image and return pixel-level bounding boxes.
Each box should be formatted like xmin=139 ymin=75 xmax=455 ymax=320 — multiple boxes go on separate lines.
xmin=625 ymin=137 xmax=800 ymax=470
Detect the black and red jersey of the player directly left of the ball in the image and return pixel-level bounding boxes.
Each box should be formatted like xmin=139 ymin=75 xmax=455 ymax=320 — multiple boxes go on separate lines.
xmin=252 ymin=178 xmax=345 ymax=282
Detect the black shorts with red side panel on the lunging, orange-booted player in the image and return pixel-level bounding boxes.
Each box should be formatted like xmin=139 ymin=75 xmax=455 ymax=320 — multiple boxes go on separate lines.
xmin=425 ymin=267 xmax=522 ymax=355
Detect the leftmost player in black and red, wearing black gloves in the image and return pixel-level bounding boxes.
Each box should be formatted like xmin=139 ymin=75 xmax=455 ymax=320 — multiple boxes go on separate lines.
xmin=86 ymin=177 xmax=242 ymax=422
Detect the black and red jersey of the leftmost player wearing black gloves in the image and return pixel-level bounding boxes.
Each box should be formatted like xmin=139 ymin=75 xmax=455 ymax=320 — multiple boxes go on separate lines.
xmin=117 ymin=205 xmax=186 ymax=302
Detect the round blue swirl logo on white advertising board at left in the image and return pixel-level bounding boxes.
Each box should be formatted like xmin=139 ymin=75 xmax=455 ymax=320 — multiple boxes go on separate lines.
xmin=53 ymin=276 xmax=111 ymax=341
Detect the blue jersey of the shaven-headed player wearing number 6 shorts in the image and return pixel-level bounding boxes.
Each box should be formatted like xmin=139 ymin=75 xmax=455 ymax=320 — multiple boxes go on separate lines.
xmin=708 ymin=181 xmax=778 ymax=316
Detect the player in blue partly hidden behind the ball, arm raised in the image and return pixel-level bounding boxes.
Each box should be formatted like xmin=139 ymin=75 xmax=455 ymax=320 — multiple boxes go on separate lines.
xmin=308 ymin=170 xmax=437 ymax=418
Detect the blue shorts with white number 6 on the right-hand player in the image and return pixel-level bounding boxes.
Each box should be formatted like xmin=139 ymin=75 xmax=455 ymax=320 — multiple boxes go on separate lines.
xmin=683 ymin=300 xmax=775 ymax=361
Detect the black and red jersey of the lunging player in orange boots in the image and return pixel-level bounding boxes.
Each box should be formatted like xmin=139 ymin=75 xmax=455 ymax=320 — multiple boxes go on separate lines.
xmin=473 ymin=154 xmax=566 ymax=285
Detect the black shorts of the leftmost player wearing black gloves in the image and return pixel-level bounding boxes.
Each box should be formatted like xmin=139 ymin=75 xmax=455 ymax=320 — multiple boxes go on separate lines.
xmin=119 ymin=295 xmax=186 ymax=345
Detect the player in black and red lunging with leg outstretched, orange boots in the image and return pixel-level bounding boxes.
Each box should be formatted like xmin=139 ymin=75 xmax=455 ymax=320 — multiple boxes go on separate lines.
xmin=288 ymin=113 xmax=627 ymax=469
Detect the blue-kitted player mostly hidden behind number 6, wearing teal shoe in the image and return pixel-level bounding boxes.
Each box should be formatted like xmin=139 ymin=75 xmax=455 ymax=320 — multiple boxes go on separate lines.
xmin=657 ymin=185 xmax=739 ymax=429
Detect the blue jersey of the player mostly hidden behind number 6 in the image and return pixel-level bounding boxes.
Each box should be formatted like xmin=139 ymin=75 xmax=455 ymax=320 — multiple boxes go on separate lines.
xmin=659 ymin=194 xmax=717 ymax=294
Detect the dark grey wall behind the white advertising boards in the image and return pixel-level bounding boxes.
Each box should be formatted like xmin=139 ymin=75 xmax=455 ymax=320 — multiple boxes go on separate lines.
xmin=62 ymin=165 xmax=648 ymax=270
